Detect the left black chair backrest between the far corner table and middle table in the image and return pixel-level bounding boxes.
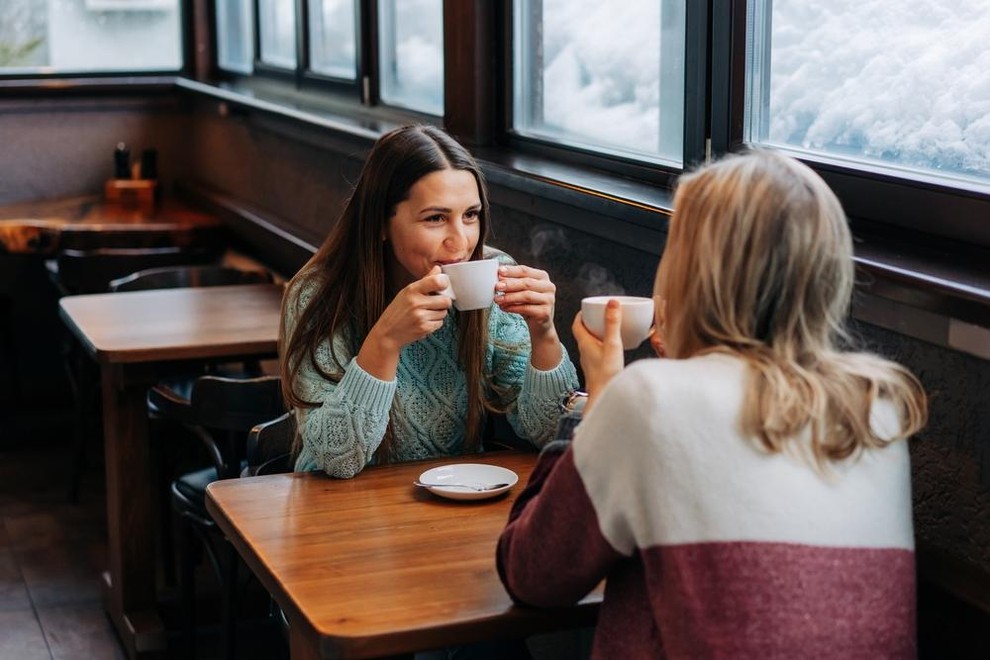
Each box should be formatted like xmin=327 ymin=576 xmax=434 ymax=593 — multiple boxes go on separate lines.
xmin=55 ymin=247 xmax=218 ymax=294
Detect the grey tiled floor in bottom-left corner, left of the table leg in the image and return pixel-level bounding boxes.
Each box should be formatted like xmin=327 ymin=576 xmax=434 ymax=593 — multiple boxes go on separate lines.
xmin=0 ymin=418 xmax=125 ymax=660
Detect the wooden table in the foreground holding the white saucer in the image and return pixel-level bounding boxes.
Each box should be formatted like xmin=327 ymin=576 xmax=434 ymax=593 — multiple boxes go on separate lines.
xmin=206 ymin=452 xmax=601 ymax=660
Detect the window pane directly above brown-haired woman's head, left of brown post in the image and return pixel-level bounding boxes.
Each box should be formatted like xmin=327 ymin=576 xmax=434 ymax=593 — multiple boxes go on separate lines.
xmin=378 ymin=0 xmax=443 ymax=115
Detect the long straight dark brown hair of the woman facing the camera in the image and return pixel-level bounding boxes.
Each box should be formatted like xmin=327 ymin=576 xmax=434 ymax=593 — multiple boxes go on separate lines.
xmin=279 ymin=125 xmax=490 ymax=463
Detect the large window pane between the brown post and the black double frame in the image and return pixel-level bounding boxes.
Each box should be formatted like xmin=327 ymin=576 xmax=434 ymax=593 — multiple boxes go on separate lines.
xmin=513 ymin=0 xmax=685 ymax=167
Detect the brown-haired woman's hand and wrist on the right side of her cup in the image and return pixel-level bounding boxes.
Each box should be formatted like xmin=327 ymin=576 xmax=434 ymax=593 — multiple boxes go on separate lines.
xmin=495 ymin=265 xmax=563 ymax=371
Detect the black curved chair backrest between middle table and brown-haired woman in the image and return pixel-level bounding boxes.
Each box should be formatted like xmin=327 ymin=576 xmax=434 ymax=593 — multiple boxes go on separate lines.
xmin=189 ymin=376 xmax=285 ymax=479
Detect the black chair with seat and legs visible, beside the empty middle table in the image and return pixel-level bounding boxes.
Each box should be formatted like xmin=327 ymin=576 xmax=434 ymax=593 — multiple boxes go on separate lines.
xmin=167 ymin=376 xmax=285 ymax=658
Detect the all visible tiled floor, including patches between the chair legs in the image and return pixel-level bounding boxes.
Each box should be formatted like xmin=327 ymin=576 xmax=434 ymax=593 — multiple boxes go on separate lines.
xmin=0 ymin=412 xmax=284 ymax=660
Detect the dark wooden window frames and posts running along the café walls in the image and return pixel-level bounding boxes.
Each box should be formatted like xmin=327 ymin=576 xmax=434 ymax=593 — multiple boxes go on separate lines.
xmin=0 ymin=0 xmax=990 ymax=253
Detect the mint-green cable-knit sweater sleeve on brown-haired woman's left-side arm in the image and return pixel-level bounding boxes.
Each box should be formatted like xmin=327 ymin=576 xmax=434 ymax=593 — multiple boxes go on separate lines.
xmin=285 ymin=278 xmax=396 ymax=479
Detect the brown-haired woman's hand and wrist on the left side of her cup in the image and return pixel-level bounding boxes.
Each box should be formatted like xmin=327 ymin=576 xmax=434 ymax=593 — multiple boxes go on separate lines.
xmin=357 ymin=266 xmax=451 ymax=380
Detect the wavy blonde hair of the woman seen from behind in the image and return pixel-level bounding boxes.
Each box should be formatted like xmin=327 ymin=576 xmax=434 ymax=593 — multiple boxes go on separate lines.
xmin=654 ymin=151 xmax=927 ymax=467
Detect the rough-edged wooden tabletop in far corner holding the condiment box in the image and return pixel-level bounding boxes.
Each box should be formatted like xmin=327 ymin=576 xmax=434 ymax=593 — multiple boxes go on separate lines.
xmin=0 ymin=195 xmax=223 ymax=255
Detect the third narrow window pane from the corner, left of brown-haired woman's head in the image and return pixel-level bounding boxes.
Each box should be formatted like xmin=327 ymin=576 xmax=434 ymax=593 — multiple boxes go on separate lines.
xmin=309 ymin=0 xmax=357 ymax=80
